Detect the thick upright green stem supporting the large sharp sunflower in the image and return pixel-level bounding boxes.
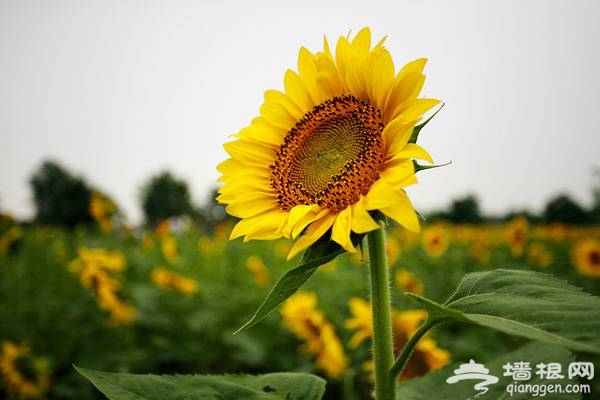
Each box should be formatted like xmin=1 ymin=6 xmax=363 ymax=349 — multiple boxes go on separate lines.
xmin=367 ymin=220 xmax=396 ymax=400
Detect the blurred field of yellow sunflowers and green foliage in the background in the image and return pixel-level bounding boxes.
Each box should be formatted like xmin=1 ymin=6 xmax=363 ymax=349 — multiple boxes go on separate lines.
xmin=0 ymin=208 xmax=600 ymax=400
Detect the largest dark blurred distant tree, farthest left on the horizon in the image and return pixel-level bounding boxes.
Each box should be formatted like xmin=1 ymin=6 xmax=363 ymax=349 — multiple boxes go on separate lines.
xmin=29 ymin=161 xmax=92 ymax=227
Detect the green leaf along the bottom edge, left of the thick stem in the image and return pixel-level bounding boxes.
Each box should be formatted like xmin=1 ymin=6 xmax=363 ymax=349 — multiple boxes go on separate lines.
xmin=75 ymin=367 xmax=325 ymax=400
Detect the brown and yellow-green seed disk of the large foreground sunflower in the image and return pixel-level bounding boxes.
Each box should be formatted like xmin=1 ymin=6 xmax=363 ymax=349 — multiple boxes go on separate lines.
xmin=271 ymin=95 xmax=384 ymax=211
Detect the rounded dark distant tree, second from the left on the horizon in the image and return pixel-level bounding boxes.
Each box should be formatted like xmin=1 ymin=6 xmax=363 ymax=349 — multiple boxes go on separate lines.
xmin=141 ymin=171 xmax=194 ymax=225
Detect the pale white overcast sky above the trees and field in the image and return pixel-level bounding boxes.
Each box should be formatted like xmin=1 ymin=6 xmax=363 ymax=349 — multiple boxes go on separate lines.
xmin=0 ymin=0 xmax=600 ymax=221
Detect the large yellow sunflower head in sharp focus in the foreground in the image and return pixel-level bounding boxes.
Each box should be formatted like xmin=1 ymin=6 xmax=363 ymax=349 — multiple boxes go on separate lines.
xmin=218 ymin=28 xmax=439 ymax=259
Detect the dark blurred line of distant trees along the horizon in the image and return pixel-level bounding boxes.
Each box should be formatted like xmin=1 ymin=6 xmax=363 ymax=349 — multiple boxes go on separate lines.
xmin=12 ymin=160 xmax=600 ymax=228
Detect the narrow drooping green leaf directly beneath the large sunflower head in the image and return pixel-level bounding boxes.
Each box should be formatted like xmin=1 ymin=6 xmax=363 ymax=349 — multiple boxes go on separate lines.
xmin=234 ymin=234 xmax=364 ymax=334
